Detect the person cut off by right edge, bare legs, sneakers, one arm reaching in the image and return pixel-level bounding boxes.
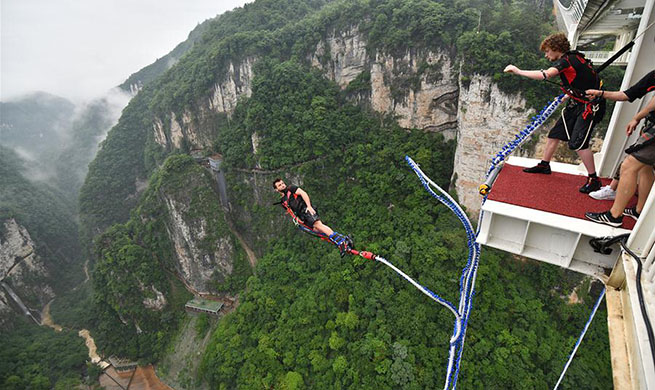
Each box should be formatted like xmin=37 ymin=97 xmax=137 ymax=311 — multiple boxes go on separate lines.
xmin=585 ymin=70 xmax=655 ymax=227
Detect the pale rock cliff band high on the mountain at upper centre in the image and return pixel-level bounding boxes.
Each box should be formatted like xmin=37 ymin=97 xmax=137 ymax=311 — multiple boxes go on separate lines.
xmin=309 ymin=26 xmax=459 ymax=138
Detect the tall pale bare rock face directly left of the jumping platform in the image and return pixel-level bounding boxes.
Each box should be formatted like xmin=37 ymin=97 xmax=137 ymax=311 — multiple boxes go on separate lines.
xmin=453 ymin=76 xmax=533 ymax=215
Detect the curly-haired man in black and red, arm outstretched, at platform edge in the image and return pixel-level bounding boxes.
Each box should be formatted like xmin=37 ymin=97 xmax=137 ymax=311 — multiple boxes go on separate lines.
xmin=504 ymin=33 xmax=605 ymax=194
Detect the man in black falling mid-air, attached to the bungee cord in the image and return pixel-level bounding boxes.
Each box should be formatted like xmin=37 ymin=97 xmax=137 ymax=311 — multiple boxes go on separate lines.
xmin=273 ymin=178 xmax=353 ymax=257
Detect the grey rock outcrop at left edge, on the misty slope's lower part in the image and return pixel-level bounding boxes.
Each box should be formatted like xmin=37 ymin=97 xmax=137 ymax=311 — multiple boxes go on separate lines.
xmin=0 ymin=219 xmax=55 ymax=323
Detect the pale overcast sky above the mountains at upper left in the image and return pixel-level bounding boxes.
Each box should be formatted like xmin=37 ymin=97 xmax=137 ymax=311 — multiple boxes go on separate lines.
xmin=0 ymin=0 xmax=253 ymax=101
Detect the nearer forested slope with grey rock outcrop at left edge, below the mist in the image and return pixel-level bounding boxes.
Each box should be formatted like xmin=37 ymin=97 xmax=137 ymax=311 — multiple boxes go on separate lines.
xmin=0 ymin=146 xmax=82 ymax=308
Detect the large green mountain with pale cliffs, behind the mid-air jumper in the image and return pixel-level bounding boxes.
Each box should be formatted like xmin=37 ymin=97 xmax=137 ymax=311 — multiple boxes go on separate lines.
xmin=0 ymin=0 xmax=611 ymax=389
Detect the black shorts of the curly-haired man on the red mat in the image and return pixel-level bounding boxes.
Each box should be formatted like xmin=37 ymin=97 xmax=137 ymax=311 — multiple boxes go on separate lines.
xmin=548 ymin=100 xmax=605 ymax=151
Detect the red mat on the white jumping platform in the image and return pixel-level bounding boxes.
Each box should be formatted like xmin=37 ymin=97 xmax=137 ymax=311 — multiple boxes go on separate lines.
xmin=488 ymin=164 xmax=637 ymax=230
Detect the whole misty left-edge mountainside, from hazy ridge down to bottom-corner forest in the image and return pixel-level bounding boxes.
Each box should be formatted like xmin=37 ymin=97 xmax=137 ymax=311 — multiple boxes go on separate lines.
xmin=0 ymin=87 xmax=128 ymax=389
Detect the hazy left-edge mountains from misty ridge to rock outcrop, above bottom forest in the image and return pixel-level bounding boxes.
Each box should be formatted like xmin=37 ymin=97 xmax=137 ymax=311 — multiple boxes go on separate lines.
xmin=0 ymin=88 xmax=126 ymax=320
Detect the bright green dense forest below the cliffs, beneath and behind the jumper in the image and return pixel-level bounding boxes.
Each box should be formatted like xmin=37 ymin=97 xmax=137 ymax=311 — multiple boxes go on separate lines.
xmin=197 ymin=58 xmax=611 ymax=389
